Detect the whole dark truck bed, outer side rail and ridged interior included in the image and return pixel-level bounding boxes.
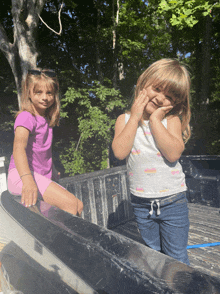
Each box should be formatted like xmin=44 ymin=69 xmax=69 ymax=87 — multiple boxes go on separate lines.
xmin=0 ymin=156 xmax=220 ymax=294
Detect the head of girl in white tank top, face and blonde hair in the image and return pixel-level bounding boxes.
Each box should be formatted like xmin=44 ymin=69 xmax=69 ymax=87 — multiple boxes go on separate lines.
xmin=134 ymin=58 xmax=190 ymax=124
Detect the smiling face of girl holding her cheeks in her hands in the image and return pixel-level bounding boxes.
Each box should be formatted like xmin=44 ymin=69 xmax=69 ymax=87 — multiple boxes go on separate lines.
xmin=145 ymin=86 xmax=176 ymax=116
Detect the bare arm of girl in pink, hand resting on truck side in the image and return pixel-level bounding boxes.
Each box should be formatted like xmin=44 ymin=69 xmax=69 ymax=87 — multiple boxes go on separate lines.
xmin=13 ymin=127 xmax=38 ymax=206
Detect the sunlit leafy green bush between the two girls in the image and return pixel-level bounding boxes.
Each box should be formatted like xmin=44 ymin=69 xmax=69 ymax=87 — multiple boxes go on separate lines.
xmin=60 ymin=81 xmax=125 ymax=175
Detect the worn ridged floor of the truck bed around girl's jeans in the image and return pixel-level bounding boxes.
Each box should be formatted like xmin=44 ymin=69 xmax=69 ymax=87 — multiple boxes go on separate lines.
xmin=113 ymin=203 xmax=220 ymax=279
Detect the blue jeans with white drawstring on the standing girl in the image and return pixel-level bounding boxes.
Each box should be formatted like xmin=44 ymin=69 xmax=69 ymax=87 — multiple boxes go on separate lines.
xmin=131 ymin=192 xmax=189 ymax=265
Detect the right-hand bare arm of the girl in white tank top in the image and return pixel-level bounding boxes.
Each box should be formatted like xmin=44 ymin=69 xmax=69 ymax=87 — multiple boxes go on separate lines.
xmin=150 ymin=107 xmax=185 ymax=162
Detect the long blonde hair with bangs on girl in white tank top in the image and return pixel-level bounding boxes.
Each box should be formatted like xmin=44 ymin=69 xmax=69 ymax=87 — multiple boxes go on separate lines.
xmin=134 ymin=58 xmax=191 ymax=142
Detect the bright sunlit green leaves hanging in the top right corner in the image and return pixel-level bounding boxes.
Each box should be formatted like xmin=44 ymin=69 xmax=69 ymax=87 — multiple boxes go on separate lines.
xmin=158 ymin=0 xmax=217 ymax=29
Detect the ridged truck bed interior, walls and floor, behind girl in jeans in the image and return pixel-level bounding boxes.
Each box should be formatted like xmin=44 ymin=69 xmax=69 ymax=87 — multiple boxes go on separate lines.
xmin=58 ymin=156 xmax=220 ymax=279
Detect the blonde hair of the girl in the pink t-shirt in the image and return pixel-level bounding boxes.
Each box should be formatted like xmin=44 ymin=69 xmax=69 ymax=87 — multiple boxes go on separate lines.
xmin=16 ymin=68 xmax=60 ymax=127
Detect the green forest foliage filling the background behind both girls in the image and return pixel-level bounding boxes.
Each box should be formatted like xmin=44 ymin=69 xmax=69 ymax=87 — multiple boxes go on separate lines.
xmin=0 ymin=0 xmax=220 ymax=169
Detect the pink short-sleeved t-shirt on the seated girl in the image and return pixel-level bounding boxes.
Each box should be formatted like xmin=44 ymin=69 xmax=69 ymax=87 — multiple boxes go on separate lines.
xmin=9 ymin=111 xmax=53 ymax=179
